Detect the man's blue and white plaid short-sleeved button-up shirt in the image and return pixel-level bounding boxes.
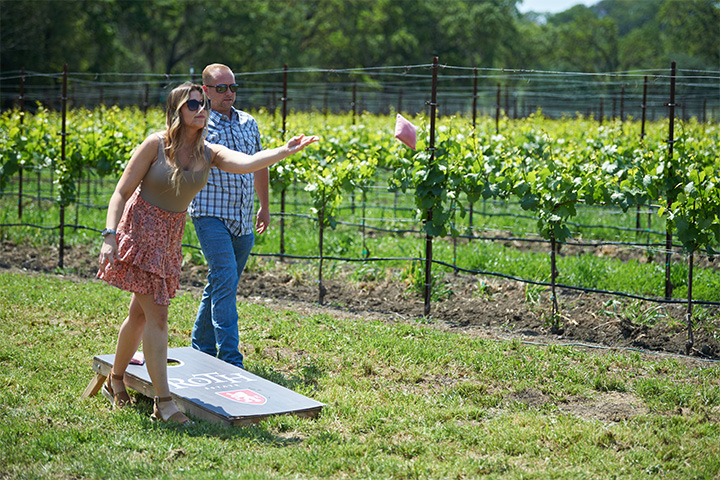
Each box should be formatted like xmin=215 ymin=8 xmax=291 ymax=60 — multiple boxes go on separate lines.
xmin=188 ymin=108 xmax=262 ymax=235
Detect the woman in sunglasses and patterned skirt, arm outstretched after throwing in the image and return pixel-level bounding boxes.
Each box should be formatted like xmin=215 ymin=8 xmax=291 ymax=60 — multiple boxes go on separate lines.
xmin=98 ymin=83 xmax=318 ymax=424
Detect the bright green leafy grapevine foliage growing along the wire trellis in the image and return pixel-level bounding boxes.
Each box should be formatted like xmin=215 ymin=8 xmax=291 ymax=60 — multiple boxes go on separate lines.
xmin=0 ymin=107 xmax=720 ymax=308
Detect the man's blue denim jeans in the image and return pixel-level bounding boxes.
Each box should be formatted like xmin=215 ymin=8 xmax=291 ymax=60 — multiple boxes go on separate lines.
xmin=191 ymin=217 xmax=255 ymax=368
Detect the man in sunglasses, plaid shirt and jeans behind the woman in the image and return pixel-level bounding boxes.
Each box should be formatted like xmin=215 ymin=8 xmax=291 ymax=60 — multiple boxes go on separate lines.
xmin=188 ymin=63 xmax=270 ymax=368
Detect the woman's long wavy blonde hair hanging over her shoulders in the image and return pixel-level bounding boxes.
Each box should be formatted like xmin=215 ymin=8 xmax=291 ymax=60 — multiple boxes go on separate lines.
xmin=165 ymin=82 xmax=210 ymax=195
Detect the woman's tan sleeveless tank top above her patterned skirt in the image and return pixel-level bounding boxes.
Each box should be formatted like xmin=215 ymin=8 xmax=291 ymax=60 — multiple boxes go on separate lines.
xmin=140 ymin=134 xmax=211 ymax=212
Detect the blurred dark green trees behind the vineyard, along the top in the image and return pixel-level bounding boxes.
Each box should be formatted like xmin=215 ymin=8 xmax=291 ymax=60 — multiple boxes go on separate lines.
xmin=0 ymin=0 xmax=720 ymax=85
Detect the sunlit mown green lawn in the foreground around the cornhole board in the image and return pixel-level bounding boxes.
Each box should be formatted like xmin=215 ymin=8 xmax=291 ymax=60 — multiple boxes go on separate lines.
xmin=0 ymin=272 xmax=720 ymax=479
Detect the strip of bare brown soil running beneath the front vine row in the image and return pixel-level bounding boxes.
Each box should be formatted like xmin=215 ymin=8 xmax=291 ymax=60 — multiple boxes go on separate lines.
xmin=0 ymin=242 xmax=720 ymax=359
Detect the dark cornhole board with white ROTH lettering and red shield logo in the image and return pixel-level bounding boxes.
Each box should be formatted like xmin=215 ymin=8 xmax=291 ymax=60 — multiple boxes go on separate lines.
xmin=82 ymin=347 xmax=325 ymax=425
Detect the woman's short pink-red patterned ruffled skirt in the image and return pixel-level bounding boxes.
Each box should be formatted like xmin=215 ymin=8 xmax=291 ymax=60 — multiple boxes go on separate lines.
xmin=97 ymin=190 xmax=185 ymax=305
